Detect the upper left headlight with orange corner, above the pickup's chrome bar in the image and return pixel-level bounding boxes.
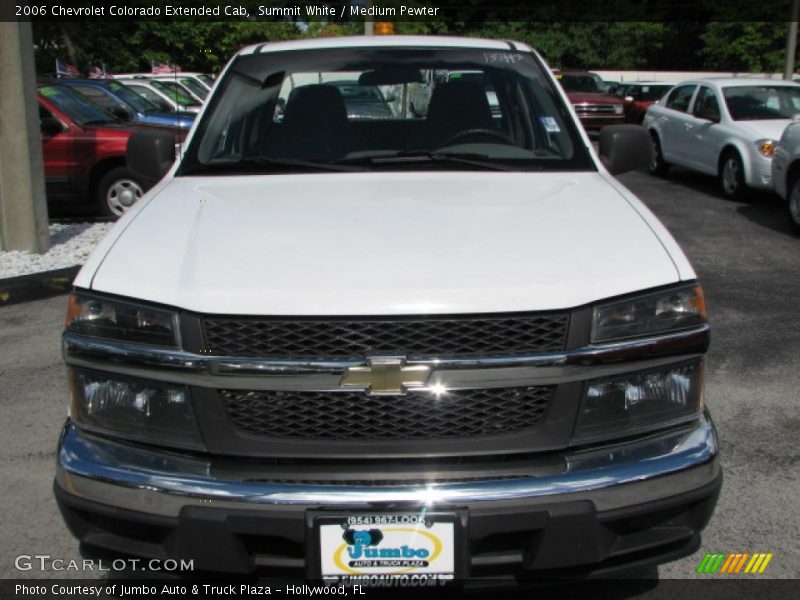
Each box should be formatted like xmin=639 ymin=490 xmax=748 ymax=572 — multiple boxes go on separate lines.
xmin=66 ymin=294 xmax=178 ymax=347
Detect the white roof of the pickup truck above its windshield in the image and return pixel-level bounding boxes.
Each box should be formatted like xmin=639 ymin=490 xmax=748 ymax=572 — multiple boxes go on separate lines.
xmin=238 ymin=35 xmax=531 ymax=56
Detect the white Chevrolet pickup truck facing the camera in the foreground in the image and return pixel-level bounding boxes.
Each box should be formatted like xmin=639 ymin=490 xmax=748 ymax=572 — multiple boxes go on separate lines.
xmin=55 ymin=36 xmax=722 ymax=586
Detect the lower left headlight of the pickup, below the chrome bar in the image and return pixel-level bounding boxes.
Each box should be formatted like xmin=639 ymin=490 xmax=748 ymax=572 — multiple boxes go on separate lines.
xmin=70 ymin=369 xmax=203 ymax=449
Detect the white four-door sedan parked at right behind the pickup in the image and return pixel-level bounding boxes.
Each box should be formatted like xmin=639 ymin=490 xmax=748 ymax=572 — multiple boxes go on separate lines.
xmin=644 ymin=78 xmax=800 ymax=199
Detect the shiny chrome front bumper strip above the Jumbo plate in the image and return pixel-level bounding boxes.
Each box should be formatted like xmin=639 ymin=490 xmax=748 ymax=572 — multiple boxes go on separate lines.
xmin=56 ymin=414 xmax=718 ymax=516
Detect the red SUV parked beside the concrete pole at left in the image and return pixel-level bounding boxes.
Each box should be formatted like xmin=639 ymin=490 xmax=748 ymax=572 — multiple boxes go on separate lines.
xmin=38 ymin=83 xmax=178 ymax=217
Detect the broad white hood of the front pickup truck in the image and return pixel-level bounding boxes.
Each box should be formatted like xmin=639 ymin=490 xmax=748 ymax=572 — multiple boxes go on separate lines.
xmin=89 ymin=172 xmax=679 ymax=315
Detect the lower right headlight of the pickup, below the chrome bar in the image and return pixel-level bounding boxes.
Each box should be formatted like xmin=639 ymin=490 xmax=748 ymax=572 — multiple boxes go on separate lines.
xmin=573 ymin=360 xmax=703 ymax=443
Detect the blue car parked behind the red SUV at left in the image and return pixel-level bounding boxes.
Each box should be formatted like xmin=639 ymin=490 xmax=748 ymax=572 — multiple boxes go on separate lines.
xmin=59 ymin=79 xmax=194 ymax=129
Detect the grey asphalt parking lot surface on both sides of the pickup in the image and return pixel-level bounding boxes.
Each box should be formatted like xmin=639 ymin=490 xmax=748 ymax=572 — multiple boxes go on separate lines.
xmin=0 ymin=165 xmax=800 ymax=597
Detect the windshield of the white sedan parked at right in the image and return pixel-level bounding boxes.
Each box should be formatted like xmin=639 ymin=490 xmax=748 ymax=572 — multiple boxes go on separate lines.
xmin=722 ymin=85 xmax=800 ymax=121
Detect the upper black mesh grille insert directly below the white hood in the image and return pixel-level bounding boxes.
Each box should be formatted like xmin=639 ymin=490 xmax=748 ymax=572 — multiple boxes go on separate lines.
xmin=203 ymin=313 xmax=569 ymax=358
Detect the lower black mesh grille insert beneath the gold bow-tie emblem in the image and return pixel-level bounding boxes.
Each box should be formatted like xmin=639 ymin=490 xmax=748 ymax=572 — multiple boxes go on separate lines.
xmin=220 ymin=386 xmax=555 ymax=440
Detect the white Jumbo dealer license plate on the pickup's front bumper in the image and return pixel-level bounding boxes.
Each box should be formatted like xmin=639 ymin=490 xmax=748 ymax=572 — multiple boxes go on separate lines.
xmin=318 ymin=513 xmax=456 ymax=581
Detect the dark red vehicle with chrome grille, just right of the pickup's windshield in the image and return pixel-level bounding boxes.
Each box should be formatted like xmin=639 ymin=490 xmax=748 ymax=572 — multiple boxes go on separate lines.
xmin=556 ymin=71 xmax=625 ymax=131
